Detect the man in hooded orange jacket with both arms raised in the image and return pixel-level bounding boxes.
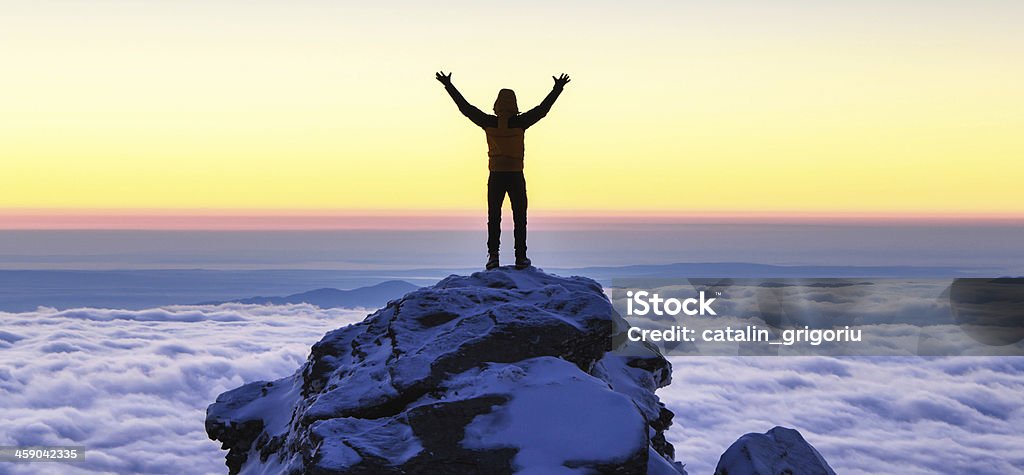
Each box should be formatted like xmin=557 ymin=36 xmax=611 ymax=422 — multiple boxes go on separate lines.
xmin=436 ymin=72 xmax=569 ymax=269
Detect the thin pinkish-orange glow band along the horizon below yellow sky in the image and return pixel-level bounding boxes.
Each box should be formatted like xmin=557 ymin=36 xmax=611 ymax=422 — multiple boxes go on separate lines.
xmin=0 ymin=209 xmax=1024 ymax=231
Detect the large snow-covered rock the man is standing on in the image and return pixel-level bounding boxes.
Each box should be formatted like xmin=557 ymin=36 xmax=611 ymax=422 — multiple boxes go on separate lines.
xmin=206 ymin=268 xmax=688 ymax=475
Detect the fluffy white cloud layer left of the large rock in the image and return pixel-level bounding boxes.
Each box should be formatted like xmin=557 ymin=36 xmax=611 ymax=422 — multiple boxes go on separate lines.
xmin=0 ymin=304 xmax=367 ymax=474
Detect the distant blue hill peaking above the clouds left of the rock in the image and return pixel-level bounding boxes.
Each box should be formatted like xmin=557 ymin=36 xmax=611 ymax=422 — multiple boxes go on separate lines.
xmin=201 ymin=280 xmax=419 ymax=308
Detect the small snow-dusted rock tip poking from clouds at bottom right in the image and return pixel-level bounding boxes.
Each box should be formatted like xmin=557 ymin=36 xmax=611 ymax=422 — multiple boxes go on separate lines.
xmin=715 ymin=427 xmax=836 ymax=475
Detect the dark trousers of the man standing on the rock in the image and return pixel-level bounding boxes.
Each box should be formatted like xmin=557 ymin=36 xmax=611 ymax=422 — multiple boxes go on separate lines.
xmin=487 ymin=168 xmax=526 ymax=256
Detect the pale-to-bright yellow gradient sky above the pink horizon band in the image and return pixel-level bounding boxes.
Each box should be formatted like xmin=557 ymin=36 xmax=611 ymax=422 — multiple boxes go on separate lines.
xmin=0 ymin=0 xmax=1024 ymax=216
